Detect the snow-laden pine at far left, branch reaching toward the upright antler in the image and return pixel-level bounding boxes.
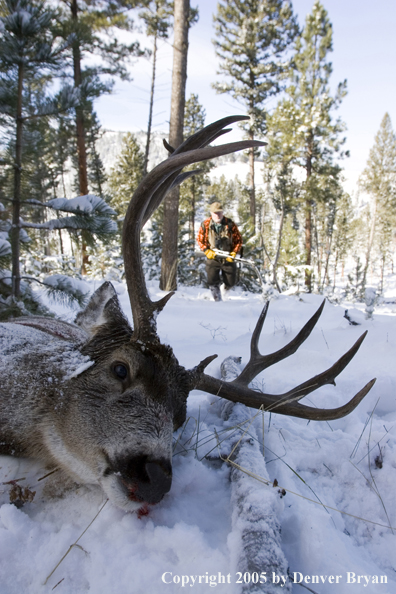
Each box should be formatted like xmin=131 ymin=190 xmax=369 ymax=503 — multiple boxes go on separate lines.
xmin=0 ymin=0 xmax=116 ymax=315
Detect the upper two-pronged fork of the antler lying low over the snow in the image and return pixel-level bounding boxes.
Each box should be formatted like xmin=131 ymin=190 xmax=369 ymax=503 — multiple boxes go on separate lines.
xmin=234 ymin=300 xmax=326 ymax=386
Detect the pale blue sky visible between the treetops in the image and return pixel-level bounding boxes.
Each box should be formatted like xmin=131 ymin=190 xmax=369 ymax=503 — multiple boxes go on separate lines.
xmin=96 ymin=0 xmax=396 ymax=191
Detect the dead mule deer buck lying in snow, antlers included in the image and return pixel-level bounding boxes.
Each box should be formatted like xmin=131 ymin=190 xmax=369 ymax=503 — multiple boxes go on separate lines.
xmin=0 ymin=116 xmax=375 ymax=511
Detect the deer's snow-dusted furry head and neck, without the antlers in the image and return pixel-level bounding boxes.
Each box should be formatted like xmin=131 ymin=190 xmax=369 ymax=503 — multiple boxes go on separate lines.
xmin=0 ymin=283 xmax=189 ymax=511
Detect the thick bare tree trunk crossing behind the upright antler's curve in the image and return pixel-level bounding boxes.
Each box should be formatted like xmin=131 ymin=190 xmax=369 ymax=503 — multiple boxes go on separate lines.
xmin=160 ymin=0 xmax=190 ymax=291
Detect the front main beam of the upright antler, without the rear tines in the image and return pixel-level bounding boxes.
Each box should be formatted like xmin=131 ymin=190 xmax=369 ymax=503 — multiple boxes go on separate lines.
xmin=123 ymin=134 xmax=265 ymax=341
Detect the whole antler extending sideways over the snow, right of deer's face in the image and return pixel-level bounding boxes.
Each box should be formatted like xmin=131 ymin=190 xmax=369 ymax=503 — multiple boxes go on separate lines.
xmin=191 ymin=301 xmax=376 ymax=421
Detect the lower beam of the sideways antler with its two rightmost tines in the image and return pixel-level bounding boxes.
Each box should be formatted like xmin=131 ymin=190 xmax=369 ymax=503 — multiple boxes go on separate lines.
xmin=196 ymin=326 xmax=376 ymax=421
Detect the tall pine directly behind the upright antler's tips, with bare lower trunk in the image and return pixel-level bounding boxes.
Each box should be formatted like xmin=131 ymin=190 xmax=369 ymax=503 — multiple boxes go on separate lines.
xmin=213 ymin=0 xmax=298 ymax=231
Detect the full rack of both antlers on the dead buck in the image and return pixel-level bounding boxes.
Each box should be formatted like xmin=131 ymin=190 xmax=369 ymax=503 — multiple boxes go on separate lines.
xmin=123 ymin=116 xmax=376 ymax=421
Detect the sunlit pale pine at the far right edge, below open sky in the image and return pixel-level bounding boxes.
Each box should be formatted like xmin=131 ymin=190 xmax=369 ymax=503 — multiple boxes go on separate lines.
xmin=359 ymin=113 xmax=396 ymax=287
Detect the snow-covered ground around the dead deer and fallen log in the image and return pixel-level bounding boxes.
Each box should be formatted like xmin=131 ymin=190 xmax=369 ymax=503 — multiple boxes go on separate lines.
xmin=0 ymin=283 xmax=396 ymax=594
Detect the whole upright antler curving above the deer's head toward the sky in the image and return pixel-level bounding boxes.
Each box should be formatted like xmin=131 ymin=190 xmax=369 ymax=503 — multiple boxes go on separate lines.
xmin=122 ymin=116 xmax=266 ymax=341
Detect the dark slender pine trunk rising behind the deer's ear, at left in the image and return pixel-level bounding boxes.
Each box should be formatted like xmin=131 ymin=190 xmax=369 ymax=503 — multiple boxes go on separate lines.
xmin=71 ymin=0 xmax=89 ymax=274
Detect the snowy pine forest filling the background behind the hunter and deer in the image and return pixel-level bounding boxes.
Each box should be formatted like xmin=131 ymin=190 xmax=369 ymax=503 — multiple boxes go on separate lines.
xmin=0 ymin=0 xmax=396 ymax=312
